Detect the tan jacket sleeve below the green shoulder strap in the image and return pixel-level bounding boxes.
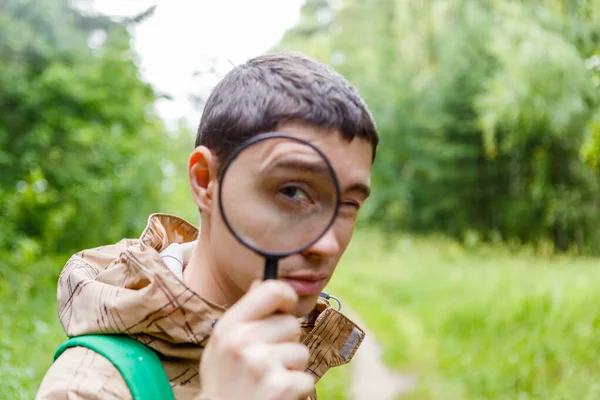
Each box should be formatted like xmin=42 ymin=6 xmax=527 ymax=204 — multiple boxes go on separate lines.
xmin=35 ymin=347 xmax=133 ymax=400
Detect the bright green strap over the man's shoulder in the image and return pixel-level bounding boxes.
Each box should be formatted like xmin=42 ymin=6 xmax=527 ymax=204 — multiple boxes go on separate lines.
xmin=54 ymin=335 xmax=175 ymax=400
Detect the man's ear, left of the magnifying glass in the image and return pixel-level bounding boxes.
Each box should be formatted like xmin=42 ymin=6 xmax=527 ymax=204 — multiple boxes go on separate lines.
xmin=188 ymin=146 xmax=217 ymax=214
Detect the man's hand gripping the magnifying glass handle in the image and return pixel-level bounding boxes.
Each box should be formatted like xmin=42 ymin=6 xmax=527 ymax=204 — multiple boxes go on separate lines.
xmin=200 ymin=280 xmax=315 ymax=400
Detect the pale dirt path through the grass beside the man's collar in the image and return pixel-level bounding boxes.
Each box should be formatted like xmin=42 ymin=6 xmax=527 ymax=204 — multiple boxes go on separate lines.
xmin=344 ymin=307 xmax=416 ymax=400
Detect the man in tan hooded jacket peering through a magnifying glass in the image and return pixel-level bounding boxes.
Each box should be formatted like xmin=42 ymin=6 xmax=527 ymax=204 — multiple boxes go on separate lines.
xmin=37 ymin=53 xmax=378 ymax=400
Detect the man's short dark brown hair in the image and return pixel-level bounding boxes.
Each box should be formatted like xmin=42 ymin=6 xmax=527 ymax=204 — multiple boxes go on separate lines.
xmin=196 ymin=52 xmax=379 ymax=170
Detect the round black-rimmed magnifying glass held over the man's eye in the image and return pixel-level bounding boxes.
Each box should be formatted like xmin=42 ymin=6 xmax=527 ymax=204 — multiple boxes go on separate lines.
xmin=218 ymin=132 xmax=340 ymax=280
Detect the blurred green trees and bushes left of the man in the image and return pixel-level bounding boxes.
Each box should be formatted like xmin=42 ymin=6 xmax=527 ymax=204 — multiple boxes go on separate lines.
xmin=0 ymin=0 xmax=183 ymax=278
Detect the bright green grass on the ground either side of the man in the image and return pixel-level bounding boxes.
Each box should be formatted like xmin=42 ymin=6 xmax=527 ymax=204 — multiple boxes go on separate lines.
xmin=0 ymin=230 xmax=600 ymax=400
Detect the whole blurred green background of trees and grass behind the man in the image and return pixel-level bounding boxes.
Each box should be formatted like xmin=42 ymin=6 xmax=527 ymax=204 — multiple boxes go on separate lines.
xmin=0 ymin=0 xmax=600 ymax=400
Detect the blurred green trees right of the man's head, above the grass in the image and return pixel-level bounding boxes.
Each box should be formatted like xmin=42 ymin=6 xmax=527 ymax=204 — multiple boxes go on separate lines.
xmin=275 ymin=0 xmax=600 ymax=254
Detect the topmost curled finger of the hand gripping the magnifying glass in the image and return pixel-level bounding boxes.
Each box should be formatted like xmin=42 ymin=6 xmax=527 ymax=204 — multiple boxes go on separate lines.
xmin=220 ymin=279 xmax=298 ymax=325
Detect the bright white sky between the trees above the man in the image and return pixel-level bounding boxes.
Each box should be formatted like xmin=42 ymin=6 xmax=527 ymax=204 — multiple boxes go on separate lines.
xmin=90 ymin=0 xmax=302 ymax=128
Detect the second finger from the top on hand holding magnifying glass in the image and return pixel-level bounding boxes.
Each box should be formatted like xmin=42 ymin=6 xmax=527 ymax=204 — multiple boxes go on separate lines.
xmin=245 ymin=314 xmax=301 ymax=343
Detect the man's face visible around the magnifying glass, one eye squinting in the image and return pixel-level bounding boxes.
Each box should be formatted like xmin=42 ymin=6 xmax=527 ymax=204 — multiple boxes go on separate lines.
xmin=203 ymin=123 xmax=372 ymax=317
